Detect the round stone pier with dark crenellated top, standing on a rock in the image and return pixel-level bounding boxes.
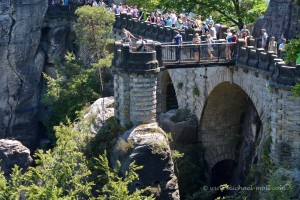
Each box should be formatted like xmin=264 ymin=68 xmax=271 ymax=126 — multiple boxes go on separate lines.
xmin=114 ymin=44 xmax=160 ymax=125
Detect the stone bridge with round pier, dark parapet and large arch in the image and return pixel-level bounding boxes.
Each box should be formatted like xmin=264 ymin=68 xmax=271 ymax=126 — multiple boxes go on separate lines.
xmin=114 ymin=15 xmax=300 ymax=169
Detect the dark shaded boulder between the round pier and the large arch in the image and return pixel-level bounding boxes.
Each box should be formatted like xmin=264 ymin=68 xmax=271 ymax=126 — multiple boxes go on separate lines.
xmin=160 ymin=110 xmax=198 ymax=143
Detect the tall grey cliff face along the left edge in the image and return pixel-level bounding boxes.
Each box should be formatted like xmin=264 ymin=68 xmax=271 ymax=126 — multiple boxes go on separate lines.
xmin=0 ymin=0 xmax=48 ymax=147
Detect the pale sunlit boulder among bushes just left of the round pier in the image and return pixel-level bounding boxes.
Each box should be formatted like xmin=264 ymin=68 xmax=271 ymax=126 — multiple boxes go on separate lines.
xmin=84 ymin=97 xmax=114 ymax=134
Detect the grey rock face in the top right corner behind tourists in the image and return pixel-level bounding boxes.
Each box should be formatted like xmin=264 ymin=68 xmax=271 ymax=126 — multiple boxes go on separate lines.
xmin=253 ymin=0 xmax=300 ymax=40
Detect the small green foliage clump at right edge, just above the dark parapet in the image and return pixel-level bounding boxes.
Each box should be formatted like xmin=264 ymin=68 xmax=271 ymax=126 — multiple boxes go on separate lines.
xmin=284 ymin=35 xmax=300 ymax=63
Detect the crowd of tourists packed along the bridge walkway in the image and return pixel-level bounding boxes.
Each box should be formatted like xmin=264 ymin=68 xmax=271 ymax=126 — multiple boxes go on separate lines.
xmin=49 ymin=0 xmax=286 ymax=60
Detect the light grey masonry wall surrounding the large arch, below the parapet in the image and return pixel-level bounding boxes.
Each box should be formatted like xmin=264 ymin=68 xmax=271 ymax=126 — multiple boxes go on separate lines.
xmin=168 ymin=66 xmax=300 ymax=167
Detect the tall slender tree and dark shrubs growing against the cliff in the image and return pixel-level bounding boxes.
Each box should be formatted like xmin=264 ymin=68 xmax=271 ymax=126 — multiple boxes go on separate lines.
xmin=43 ymin=6 xmax=115 ymax=137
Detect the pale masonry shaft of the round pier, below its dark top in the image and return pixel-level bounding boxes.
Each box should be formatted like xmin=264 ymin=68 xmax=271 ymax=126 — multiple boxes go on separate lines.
xmin=114 ymin=72 xmax=157 ymax=126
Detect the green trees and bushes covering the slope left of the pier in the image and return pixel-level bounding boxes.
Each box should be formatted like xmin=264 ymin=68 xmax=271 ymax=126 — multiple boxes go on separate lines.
xmin=0 ymin=6 xmax=153 ymax=200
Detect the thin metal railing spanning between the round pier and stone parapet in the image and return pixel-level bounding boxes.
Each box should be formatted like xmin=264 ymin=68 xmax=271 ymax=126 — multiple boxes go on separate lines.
xmin=162 ymin=42 xmax=236 ymax=64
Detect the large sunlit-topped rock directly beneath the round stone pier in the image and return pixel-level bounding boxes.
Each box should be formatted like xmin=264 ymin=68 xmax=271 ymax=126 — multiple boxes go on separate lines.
xmin=111 ymin=124 xmax=179 ymax=200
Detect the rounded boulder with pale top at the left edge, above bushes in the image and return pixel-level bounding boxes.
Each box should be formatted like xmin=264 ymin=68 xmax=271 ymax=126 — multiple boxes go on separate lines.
xmin=0 ymin=139 xmax=32 ymax=176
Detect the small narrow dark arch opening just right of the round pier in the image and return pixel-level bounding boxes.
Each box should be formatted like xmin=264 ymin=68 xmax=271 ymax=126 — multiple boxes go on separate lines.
xmin=160 ymin=70 xmax=178 ymax=113
